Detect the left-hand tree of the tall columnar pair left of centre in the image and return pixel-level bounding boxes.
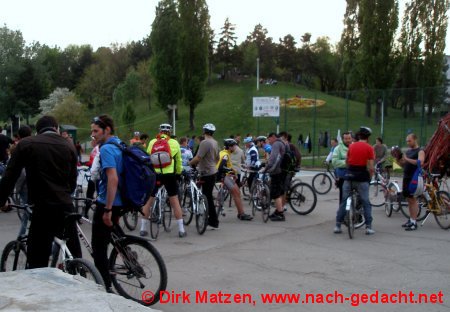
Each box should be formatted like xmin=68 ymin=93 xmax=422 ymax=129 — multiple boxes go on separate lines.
xmin=150 ymin=0 xmax=182 ymax=120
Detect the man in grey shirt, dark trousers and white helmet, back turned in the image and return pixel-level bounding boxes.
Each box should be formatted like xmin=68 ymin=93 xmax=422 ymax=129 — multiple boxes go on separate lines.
xmin=189 ymin=123 xmax=219 ymax=229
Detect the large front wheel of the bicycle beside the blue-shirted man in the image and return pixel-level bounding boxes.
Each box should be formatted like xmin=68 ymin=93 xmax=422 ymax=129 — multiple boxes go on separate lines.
xmin=109 ymin=237 xmax=167 ymax=306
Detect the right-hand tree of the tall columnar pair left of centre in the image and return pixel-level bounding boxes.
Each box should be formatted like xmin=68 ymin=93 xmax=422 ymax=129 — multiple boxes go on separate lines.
xmin=178 ymin=0 xmax=211 ymax=130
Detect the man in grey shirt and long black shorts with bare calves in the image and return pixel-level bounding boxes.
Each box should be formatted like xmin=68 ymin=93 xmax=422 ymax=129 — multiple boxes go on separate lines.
xmin=264 ymin=133 xmax=286 ymax=221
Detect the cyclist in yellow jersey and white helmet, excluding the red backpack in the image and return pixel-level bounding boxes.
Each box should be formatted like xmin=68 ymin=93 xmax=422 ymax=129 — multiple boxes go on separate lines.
xmin=140 ymin=124 xmax=187 ymax=237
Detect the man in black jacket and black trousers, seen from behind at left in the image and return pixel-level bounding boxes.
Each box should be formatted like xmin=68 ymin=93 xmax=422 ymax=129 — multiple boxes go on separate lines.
xmin=0 ymin=116 xmax=81 ymax=269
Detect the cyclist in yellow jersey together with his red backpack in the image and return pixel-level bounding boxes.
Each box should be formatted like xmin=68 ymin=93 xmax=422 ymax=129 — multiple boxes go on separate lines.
xmin=140 ymin=124 xmax=187 ymax=237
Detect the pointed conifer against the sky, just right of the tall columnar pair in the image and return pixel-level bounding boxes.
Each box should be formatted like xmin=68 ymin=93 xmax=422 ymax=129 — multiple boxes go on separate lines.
xmin=216 ymin=17 xmax=237 ymax=77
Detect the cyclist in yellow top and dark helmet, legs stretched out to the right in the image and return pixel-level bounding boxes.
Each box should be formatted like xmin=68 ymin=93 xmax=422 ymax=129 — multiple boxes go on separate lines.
xmin=216 ymin=139 xmax=253 ymax=221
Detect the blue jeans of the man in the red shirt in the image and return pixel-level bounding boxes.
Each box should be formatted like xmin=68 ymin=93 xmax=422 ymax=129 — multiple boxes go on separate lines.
xmin=336 ymin=180 xmax=373 ymax=227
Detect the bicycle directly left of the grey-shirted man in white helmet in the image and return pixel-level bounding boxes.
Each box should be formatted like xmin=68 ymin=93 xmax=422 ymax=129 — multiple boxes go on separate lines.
xmin=180 ymin=170 xmax=208 ymax=235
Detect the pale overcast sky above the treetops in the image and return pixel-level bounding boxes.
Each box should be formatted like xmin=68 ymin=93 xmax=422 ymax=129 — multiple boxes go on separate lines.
xmin=0 ymin=0 xmax=450 ymax=54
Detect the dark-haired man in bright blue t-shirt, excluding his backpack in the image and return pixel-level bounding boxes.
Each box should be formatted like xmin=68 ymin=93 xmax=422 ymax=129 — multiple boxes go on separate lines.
xmin=91 ymin=115 xmax=124 ymax=292
